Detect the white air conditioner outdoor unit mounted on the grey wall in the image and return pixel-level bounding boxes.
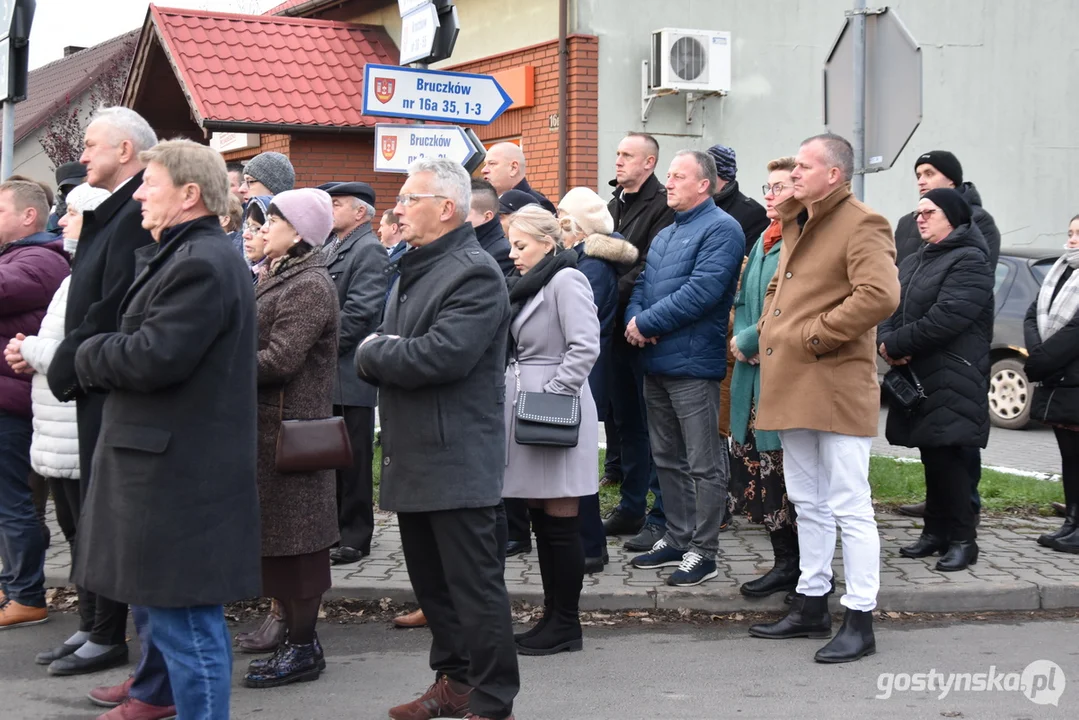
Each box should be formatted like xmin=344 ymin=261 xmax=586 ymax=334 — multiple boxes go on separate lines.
xmin=650 ymin=28 xmax=730 ymax=94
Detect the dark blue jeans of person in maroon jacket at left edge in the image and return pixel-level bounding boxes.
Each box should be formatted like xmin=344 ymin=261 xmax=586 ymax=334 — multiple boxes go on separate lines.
xmin=0 ymin=410 xmax=45 ymax=608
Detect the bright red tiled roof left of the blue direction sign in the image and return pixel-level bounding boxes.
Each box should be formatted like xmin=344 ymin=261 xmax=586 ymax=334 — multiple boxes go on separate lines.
xmin=141 ymin=5 xmax=397 ymax=130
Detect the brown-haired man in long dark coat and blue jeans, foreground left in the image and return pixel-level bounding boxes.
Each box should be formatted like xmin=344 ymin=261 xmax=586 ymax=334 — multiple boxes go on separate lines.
xmin=73 ymin=140 xmax=261 ymax=718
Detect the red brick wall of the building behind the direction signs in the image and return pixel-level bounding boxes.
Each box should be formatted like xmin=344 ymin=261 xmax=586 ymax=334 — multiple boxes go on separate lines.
xmin=215 ymin=35 xmax=599 ymax=213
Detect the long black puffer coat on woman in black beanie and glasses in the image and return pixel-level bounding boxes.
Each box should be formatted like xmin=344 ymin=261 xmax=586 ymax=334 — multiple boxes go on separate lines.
xmin=877 ymin=223 xmax=993 ymax=448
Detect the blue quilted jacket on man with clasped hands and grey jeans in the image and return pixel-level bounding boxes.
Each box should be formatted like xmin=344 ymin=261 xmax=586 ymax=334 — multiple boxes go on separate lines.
xmin=626 ymin=197 xmax=746 ymax=380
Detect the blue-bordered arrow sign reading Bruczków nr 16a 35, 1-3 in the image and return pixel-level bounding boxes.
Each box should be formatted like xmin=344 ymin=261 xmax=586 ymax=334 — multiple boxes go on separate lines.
xmin=364 ymin=63 xmax=514 ymax=125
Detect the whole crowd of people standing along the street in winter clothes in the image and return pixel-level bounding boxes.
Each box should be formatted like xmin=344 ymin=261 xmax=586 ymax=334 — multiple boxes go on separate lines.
xmin=0 ymin=101 xmax=1079 ymax=720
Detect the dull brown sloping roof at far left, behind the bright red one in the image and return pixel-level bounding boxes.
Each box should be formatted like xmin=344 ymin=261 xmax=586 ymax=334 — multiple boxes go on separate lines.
xmin=0 ymin=30 xmax=138 ymax=142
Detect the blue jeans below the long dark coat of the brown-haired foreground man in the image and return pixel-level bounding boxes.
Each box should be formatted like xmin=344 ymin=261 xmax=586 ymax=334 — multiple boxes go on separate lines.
xmin=146 ymin=604 xmax=232 ymax=720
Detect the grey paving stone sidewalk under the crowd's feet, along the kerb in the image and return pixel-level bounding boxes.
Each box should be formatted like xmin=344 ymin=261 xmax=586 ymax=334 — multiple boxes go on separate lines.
xmin=45 ymin=513 xmax=1079 ymax=612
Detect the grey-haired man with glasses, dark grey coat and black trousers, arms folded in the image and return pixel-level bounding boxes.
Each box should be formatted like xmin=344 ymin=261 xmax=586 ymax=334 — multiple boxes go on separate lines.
xmin=356 ymin=159 xmax=520 ymax=720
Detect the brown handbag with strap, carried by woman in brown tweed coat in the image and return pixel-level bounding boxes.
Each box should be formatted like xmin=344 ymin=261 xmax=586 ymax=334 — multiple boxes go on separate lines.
xmin=276 ymin=388 xmax=352 ymax=473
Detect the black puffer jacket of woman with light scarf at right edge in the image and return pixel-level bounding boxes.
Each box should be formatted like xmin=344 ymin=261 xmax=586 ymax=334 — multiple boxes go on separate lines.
xmin=1023 ymin=264 xmax=1079 ymax=427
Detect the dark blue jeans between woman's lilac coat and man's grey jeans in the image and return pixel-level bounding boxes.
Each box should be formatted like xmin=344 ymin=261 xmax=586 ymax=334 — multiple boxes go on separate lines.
xmin=611 ymin=338 xmax=667 ymax=527
